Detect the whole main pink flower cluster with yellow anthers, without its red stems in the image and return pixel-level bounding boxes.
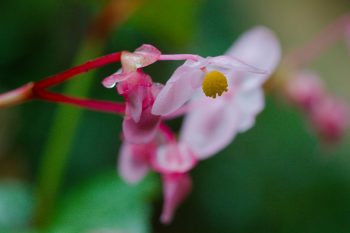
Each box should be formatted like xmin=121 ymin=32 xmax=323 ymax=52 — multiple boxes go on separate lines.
xmin=103 ymin=27 xmax=280 ymax=223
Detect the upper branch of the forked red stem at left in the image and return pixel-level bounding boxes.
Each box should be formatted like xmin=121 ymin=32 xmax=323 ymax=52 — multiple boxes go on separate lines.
xmin=35 ymin=52 xmax=121 ymax=90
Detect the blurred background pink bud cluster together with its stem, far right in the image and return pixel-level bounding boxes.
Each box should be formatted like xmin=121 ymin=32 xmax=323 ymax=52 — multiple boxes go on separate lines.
xmin=283 ymin=14 xmax=350 ymax=143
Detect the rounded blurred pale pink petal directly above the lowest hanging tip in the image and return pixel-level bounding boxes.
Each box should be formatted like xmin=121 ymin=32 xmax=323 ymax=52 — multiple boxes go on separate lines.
xmin=151 ymin=143 xmax=197 ymax=173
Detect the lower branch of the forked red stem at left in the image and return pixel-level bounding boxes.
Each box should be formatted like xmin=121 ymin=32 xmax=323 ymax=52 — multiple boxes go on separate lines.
xmin=34 ymin=90 xmax=125 ymax=115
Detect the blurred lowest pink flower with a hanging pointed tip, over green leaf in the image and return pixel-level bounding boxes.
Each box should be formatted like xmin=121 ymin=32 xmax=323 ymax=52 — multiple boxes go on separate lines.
xmin=118 ymin=137 xmax=197 ymax=223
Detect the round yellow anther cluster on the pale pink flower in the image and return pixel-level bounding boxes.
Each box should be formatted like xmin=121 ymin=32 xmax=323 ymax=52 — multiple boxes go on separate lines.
xmin=202 ymin=70 xmax=228 ymax=99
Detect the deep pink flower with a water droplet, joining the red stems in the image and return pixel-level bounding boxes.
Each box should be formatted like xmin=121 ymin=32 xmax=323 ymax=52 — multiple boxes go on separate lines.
xmin=102 ymin=45 xmax=161 ymax=143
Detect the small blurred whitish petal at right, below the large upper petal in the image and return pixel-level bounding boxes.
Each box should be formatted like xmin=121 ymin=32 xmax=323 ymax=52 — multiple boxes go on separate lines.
xmin=232 ymin=88 xmax=265 ymax=132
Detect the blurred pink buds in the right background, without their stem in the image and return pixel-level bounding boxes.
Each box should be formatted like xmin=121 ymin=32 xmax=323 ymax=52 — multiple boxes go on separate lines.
xmin=286 ymin=71 xmax=350 ymax=143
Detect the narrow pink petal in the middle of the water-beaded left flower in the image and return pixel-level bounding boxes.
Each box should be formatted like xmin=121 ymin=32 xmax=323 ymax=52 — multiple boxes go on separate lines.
xmin=125 ymin=86 xmax=147 ymax=122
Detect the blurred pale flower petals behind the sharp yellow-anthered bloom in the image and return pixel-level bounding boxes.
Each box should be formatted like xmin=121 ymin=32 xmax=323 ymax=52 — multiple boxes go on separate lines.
xmin=180 ymin=27 xmax=280 ymax=159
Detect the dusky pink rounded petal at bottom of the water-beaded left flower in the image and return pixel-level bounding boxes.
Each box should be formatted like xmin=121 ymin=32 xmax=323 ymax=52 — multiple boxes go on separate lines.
xmin=123 ymin=107 xmax=161 ymax=144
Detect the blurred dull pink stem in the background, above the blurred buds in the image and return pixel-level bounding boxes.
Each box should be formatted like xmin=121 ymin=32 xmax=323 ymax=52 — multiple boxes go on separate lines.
xmin=286 ymin=15 xmax=350 ymax=67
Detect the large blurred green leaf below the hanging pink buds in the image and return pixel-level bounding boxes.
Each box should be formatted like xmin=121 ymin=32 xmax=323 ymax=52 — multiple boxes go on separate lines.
xmin=48 ymin=172 xmax=157 ymax=233
